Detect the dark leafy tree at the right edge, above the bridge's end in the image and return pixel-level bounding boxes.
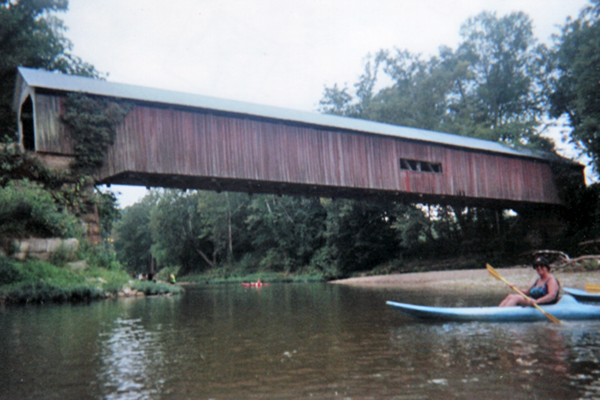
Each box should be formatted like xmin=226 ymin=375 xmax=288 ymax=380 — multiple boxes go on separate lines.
xmin=550 ymin=0 xmax=600 ymax=172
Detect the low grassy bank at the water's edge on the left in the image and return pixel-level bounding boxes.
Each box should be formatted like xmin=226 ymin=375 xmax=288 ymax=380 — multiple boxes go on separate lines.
xmin=0 ymin=253 xmax=183 ymax=304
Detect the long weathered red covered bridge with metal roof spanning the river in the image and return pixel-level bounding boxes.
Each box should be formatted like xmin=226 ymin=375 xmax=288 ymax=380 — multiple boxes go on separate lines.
xmin=14 ymin=68 xmax=583 ymax=208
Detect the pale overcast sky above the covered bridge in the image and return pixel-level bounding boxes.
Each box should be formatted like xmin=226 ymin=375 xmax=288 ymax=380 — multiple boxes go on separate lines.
xmin=60 ymin=0 xmax=588 ymax=207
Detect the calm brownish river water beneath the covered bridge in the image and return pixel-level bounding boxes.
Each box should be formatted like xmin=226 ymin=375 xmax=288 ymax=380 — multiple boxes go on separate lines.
xmin=0 ymin=283 xmax=600 ymax=400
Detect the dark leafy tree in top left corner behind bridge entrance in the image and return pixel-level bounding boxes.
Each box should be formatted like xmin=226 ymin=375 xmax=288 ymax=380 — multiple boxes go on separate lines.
xmin=0 ymin=0 xmax=100 ymax=142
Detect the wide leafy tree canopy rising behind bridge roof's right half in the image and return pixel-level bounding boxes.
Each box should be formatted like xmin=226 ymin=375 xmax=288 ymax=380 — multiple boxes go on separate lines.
xmin=320 ymin=12 xmax=553 ymax=150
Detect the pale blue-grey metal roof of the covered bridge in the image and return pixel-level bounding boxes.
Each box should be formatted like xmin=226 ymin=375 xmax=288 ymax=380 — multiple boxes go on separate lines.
xmin=15 ymin=67 xmax=546 ymax=158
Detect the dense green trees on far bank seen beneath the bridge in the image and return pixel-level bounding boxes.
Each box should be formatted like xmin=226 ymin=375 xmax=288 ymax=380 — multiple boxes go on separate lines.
xmin=115 ymin=190 xmax=513 ymax=280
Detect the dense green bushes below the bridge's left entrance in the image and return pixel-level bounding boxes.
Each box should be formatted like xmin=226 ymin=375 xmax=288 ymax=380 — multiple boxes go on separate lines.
xmin=0 ymin=145 xmax=120 ymax=238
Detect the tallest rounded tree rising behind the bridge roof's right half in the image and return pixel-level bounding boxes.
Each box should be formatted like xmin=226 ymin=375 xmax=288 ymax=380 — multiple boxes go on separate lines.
xmin=457 ymin=12 xmax=545 ymax=145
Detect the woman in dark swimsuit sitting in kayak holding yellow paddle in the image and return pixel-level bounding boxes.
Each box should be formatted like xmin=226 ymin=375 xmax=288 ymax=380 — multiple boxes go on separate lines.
xmin=500 ymin=257 xmax=560 ymax=307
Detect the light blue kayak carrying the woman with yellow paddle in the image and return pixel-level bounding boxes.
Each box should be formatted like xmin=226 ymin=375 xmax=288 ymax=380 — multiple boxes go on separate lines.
xmin=387 ymin=295 xmax=600 ymax=322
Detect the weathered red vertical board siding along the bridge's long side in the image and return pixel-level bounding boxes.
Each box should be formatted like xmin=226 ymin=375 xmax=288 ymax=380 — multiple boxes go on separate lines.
xmin=84 ymin=102 xmax=560 ymax=204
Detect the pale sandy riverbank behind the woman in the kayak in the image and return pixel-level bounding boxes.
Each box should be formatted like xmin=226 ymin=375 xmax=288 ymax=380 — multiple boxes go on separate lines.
xmin=331 ymin=267 xmax=600 ymax=293
